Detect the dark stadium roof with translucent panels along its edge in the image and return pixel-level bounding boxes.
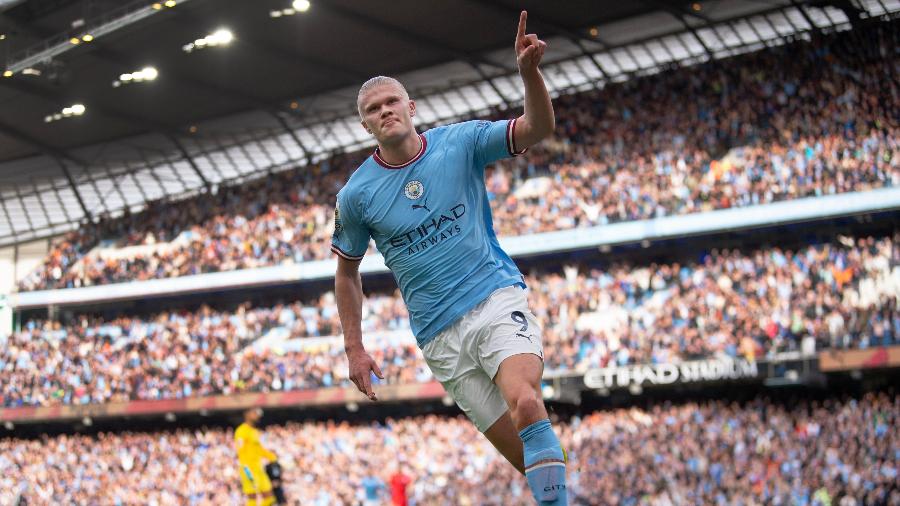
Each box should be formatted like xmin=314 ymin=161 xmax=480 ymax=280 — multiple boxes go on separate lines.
xmin=0 ymin=0 xmax=900 ymax=245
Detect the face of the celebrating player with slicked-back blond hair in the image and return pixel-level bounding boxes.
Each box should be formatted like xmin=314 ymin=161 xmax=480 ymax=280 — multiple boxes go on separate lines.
xmin=359 ymin=84 xmax=416 ymax=144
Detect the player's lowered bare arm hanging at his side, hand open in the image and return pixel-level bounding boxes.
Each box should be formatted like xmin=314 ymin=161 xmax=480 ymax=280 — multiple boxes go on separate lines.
xmin=334 ymin=256 xmax=384 ymax=401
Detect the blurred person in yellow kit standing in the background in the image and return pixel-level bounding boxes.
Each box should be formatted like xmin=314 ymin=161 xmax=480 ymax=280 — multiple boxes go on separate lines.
xmin=234 ymin=408 xmax=278 ymax=506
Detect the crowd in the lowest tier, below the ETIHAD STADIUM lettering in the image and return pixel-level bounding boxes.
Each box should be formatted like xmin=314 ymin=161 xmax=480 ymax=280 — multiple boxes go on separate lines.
xmin=0 ymin=392 xmax=900 ymax=506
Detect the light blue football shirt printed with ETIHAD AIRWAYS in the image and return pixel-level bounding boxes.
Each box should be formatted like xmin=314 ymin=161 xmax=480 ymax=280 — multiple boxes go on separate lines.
xmin=331 ymin=119 xmax=524 ymax=347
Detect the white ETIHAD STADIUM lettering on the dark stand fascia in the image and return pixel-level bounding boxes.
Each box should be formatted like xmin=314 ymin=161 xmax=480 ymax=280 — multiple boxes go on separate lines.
xmin=584 ymin=359 xmax=759 ymax=389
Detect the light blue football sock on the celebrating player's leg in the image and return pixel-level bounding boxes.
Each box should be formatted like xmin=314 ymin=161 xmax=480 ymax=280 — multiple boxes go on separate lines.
xmin=519 ymin=419 xmax=568 ymax=506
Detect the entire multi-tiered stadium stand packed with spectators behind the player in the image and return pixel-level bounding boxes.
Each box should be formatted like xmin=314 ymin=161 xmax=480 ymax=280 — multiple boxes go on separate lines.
xmin=0 ymin=1 xmax=900 ymax=506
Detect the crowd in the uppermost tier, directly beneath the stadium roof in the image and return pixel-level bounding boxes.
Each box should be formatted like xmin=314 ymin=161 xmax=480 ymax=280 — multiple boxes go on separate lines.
xmin=19 ymin=21 xmax=900 ymax=290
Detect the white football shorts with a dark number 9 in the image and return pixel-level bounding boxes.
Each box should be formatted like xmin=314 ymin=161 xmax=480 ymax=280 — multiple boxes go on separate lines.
xmin=422 ymin=286 xmax=544 ymax=432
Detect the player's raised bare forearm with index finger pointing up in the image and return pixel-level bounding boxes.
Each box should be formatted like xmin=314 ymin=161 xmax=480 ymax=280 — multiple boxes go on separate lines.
xmin=513 ymin=11 xmax=556 ymax=152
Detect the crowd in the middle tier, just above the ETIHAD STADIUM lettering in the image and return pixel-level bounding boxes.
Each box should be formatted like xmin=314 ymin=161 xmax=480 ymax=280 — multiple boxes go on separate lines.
xmin=0 ymin=237 xmax=900 ymax=407
